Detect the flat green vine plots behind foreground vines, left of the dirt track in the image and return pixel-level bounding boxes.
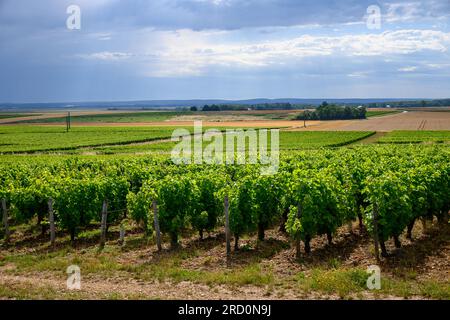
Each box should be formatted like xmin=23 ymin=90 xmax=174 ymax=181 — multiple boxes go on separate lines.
xmin=0 ymin=126 xmax=373 ymax=153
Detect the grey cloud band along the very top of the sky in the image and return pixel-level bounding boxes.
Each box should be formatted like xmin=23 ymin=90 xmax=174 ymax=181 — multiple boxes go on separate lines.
xmin=0 ymin=0 xmax=450 ymax=30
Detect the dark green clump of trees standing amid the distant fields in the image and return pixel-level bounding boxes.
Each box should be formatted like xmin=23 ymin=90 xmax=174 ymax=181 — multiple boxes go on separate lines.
xmin=297 ymin=102 xmax=367 ymax=120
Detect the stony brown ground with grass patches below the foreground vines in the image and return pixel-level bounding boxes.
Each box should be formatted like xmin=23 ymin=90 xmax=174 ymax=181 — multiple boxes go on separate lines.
xmin=0 ymin=223 xmax=450 ymax=299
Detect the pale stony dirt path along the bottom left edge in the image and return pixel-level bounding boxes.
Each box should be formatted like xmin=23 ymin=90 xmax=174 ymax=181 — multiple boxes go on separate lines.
xmin=0 ymin=270 xmax=339 ymax=300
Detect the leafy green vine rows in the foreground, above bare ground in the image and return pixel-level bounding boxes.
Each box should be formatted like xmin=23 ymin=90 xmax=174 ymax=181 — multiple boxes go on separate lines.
xmin=0 ymin=146 xmax=450 ymax=256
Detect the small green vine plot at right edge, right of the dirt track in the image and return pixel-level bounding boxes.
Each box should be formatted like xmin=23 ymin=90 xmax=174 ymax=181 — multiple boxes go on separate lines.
xmin=378 ymin=130 xmax=450 ymax=143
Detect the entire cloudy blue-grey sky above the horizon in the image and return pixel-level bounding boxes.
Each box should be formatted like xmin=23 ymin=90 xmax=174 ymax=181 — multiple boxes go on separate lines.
xmin=0 ymin=0 xmax=450 ymax=103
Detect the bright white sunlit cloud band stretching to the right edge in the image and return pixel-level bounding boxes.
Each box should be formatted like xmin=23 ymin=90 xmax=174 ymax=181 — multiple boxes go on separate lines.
xmin=128 ymin=30 xmax=450 ymax=77
